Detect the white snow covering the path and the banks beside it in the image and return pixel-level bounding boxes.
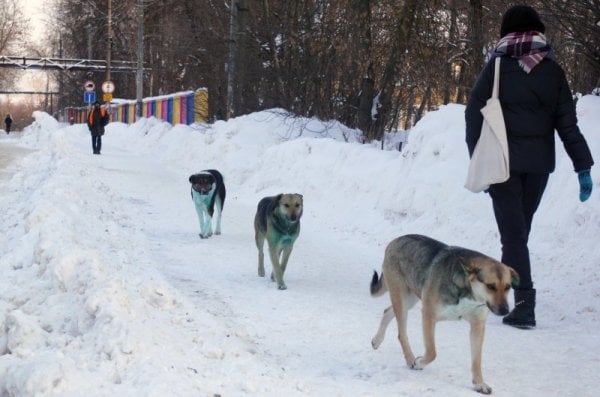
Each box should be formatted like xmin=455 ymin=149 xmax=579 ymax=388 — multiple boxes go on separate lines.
xmin=0 ymin=96 xmax=600 ymax=397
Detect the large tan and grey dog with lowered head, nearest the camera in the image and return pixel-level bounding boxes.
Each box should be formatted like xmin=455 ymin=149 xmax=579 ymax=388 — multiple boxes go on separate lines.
xmin=371 ymin=234 xmax=519 ymax=394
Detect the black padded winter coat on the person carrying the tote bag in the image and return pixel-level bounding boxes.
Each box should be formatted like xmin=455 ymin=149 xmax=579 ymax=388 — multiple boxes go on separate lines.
xmin=465 ymin=57 xmax=594 ymax=173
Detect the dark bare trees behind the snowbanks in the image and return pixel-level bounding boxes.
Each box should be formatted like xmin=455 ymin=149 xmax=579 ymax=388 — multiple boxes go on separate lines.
xmin=49 ymin=0 xmax=600 ymax=139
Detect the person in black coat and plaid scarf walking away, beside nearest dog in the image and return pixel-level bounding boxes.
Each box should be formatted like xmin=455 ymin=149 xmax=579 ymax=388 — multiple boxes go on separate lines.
xmin=465 ymin=5 xmax=594 ymax=328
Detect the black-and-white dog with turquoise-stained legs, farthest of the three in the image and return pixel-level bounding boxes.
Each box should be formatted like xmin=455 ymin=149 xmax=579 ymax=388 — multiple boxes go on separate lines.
xmin=189 ymin=170 xmax=225 ymax=238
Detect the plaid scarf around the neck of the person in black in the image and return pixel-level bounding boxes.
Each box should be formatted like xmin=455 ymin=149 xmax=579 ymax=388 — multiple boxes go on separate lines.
xmin=494 ymin=31 xmax=554 ymax=73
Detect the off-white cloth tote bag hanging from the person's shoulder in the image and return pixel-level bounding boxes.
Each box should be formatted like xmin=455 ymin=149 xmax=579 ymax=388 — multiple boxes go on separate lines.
xmin=465 ymin=57 xmax=510 ymax=193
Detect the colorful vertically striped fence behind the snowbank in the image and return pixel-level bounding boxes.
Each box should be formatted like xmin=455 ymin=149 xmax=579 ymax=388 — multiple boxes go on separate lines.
xmin=59 ymin=88 xmax=208 ymax=125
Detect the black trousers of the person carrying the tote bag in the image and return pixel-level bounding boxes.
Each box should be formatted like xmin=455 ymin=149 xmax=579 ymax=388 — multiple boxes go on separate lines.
xmin=489 ymin=171 xmax=549 ymax=290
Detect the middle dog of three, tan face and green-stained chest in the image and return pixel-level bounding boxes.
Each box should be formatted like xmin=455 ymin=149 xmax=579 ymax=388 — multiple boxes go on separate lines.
xmin=254 ymin=193 xmax=303 ymax=290
